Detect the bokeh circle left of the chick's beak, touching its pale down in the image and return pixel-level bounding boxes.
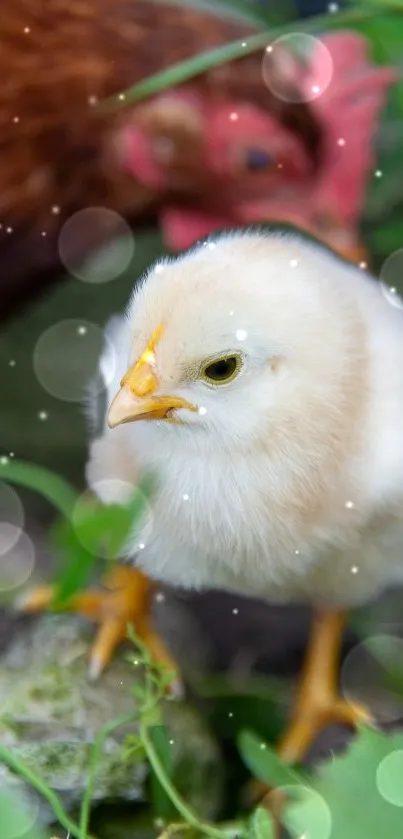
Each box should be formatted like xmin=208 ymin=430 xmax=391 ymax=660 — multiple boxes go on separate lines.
xmin=33 ymin=318 xmax=117 ymax=402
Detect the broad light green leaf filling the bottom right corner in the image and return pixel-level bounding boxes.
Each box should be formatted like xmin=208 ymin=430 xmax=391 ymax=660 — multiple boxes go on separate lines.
xmin=283 ymin=728 xmax=403 ymax=839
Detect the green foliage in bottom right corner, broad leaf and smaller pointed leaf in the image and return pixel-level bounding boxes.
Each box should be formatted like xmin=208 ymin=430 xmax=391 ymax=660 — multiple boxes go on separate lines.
xmin=239 ymin=727 xmax=403 ymax=839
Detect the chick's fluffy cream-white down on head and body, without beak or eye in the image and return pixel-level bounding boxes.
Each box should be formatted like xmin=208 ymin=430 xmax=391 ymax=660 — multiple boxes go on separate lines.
xmin=87 ymin=231 xmax=403 ymax=608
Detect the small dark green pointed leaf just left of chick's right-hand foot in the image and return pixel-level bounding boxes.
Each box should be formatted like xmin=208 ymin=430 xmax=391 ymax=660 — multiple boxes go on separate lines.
xmin=238 ymin=730 xmax=306 ymax=788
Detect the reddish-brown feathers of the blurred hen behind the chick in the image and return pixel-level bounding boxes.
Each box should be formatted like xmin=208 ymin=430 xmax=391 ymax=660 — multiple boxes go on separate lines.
xmin=0 ymin=0 xmax=317 ymax=225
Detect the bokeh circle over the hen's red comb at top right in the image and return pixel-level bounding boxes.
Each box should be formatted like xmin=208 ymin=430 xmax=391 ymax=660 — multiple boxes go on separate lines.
xmin=261 ymin=32 xmax=333 ymax=103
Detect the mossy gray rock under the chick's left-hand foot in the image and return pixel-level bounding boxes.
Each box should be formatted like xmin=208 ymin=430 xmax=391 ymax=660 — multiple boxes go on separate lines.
xmin=0 ymin=615 xmax=221 ymax=823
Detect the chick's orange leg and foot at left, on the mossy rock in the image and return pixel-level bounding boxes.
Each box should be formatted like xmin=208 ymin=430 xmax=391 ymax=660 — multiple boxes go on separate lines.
xmin=18 ymin=565 xmax=177 ymax=678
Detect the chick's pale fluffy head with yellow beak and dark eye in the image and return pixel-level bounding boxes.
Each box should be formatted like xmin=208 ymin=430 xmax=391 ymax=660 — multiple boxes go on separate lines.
xmin=109 ymin=232 xmax=364 ymax=452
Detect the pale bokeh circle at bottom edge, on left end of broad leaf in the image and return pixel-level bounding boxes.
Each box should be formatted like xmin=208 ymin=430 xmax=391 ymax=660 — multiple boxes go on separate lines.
xmin=276 ymin=785 xmax=332 ymax=839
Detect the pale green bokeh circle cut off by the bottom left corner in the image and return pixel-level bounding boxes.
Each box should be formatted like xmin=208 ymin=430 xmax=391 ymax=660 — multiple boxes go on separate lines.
xmin=0 ymin=778 xmax=40 ymax=839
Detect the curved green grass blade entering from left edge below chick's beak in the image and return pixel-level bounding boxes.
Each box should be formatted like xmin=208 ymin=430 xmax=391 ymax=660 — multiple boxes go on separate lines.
xmin=0 ymin=461 xmax=78 ymax=519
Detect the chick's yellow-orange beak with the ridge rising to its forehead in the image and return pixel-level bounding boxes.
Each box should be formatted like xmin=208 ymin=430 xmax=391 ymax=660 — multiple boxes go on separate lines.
xmin=108 ymin=327 xmax=197 ymax=428
